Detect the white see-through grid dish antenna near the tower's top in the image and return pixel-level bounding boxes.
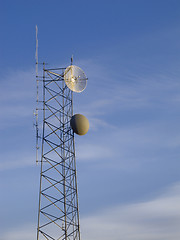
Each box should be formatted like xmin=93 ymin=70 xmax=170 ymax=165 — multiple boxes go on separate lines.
xmin=64 ymin=65 xmax=87 ymax=92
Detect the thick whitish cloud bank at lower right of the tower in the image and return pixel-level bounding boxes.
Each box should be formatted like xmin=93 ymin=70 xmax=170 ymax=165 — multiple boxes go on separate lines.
xmin=81 ymin=184 xmax=180 ymax=240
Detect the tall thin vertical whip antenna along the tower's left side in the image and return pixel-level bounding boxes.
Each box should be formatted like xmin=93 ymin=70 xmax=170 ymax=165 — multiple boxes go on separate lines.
xmin=35 ymin=25 xmax=39 ymax=165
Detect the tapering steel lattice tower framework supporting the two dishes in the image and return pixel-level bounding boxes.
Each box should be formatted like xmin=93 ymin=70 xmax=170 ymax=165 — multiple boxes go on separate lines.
xmin=37 ymin=68 xmax=80 ymax=240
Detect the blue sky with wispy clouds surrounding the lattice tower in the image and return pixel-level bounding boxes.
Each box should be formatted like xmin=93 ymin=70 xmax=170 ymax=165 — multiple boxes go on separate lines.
xmin=0 ymin=0 xmax=180 ymax=240
